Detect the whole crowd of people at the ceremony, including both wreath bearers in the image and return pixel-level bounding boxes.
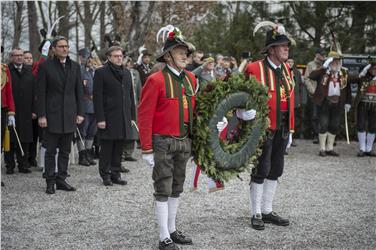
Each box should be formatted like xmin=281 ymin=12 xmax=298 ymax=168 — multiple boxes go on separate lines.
xmin=1 ymin=21 xmax=376 ymax=249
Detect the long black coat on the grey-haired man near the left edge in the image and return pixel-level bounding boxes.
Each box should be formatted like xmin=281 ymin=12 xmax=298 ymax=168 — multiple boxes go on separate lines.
xmin=8 ymin=64 xmax=36 ymax=143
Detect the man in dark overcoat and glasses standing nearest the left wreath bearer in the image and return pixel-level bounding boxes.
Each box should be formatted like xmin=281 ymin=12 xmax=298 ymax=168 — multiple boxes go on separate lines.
xmin=93 ymin=46 xmax=136 ymax=186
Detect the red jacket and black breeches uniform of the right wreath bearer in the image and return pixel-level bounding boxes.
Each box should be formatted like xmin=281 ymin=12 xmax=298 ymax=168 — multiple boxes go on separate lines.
xmin=245 ymin=59 xmax=294 ymax=184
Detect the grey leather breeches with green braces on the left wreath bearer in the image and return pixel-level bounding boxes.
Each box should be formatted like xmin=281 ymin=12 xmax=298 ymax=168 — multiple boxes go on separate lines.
xmin=152 ymin=67 xmax=195 ymax=202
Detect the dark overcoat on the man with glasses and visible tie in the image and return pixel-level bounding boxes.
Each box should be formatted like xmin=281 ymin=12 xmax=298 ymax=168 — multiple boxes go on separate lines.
xmin=37 ymin=57 xmax=84 ymax=134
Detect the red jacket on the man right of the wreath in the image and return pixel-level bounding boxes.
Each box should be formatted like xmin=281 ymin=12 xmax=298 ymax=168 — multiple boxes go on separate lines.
xmin=244 ymin=59 xmax=295 ymax=132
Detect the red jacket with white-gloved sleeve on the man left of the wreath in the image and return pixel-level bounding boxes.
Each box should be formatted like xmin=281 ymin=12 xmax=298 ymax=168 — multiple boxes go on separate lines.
xmin=138 ymin=69 xmax=197 ymax=153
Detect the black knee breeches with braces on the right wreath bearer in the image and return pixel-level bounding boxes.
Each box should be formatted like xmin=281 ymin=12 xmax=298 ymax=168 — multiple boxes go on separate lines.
xmin=251 ymin=60 xmax=294 ymax=184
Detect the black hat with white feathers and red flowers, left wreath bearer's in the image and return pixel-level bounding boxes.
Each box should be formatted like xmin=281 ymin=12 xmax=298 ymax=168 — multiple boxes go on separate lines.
xmin=157 ymin=24 xmax=195 ymax=62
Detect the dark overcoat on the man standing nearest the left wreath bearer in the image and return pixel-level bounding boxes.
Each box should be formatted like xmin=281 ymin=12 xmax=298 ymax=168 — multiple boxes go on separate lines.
xmin=93 ymin=64 xmax=136 ymax=140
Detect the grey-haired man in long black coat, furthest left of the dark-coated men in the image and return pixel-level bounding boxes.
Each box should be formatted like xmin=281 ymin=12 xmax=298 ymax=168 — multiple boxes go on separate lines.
xmin=4 ymin=48 xmax=36 ymax=174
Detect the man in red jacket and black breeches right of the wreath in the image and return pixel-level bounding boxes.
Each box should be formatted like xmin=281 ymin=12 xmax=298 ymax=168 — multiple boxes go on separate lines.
xmin=245 ymin=25 xmax=294 ymax=230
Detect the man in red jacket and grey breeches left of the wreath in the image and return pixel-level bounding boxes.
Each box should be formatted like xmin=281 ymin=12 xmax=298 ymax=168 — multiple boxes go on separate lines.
xmin=138 ymin=25 xmax=197 ymax=249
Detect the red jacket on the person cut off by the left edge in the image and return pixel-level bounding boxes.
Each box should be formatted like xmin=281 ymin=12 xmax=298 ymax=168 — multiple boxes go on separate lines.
xmin=1 ymin=64 xmax=16 ymax=115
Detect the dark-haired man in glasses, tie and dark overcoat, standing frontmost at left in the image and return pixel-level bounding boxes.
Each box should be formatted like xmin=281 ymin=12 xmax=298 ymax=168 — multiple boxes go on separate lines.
xmin=37 ymin=36 xmax=84 ymax=194
